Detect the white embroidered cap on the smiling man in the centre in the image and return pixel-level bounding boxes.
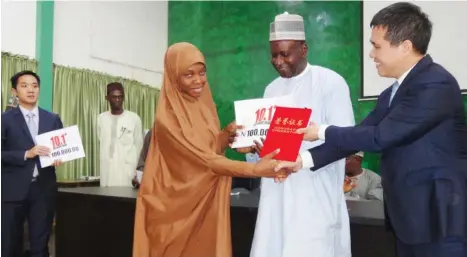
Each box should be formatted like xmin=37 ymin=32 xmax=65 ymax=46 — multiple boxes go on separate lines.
xmin=269 ymin=12 xmax=305 ymax=41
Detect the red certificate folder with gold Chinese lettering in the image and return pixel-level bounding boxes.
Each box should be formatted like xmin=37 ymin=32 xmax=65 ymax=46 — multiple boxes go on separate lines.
xmin=260 ymin=106 xmax=311 ymax=162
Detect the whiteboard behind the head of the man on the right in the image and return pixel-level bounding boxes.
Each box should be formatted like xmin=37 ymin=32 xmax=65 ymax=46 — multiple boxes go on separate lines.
xmin=362 ymin=1 xmax=467 ymax=98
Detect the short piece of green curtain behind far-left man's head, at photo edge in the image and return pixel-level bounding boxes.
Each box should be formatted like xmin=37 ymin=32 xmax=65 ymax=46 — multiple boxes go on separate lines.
xmin=2 ymin=52 xmax=37 ymax=111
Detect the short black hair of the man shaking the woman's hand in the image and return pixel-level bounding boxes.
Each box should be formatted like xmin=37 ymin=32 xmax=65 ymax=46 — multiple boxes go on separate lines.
xmin=370 ymin=2 xmax=432 ymax=55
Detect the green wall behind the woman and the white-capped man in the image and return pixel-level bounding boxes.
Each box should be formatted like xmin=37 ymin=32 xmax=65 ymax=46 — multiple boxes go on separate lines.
xmin=169 ymin=1 xmax=467 ymax=171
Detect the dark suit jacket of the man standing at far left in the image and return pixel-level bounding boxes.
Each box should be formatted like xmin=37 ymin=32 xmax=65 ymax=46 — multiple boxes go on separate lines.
xmin=2 ymin=105 xmax=63 ymax=201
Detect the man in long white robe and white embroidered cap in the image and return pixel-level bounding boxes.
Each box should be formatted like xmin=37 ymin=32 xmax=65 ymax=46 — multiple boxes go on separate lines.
xmin=250 ymin=13 xmax=355 ymax=257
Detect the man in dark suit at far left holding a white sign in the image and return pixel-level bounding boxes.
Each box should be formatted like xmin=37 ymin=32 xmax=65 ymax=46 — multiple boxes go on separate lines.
xmin=1 ymin=71 xmax=63 ymax=257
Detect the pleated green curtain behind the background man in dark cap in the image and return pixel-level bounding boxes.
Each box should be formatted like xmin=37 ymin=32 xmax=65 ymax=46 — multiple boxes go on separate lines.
xmin=53 ymin=65 xmax=159 ymax=181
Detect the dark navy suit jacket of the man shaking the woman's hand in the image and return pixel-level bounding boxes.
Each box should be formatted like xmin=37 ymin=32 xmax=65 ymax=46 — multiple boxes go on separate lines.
xmin=310 ymin=55 xmax=467 ymax=244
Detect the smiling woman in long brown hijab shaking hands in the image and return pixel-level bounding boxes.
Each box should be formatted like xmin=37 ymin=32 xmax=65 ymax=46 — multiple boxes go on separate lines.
xmin=133 ymin=43 xmax=286 ymax=257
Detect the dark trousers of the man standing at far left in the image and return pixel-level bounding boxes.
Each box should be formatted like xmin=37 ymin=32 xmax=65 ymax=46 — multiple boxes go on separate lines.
xmin=2 ymin=181 xmax=57 ymax=257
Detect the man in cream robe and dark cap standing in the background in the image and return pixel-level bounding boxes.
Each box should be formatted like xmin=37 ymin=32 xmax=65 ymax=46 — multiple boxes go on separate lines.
xmin=97 ymin=82 xmax=143 ymax=187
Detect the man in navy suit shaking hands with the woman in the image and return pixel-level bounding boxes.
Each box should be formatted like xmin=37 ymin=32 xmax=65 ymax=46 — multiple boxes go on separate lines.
xmin=277 ymin=3 xmax=467 ymax=257
